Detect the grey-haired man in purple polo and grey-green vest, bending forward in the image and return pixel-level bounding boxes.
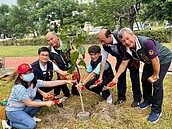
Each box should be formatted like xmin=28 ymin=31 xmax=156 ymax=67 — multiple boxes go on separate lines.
xmin=112 ymin=28 xmax=172 ymax=122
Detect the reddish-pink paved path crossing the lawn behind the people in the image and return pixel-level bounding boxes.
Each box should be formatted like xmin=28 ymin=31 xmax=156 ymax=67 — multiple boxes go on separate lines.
xmin=3 ymin=55 xmax=172 ymax=74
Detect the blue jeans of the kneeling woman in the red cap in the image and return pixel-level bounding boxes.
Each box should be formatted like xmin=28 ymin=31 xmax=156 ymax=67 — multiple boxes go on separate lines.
xmin=6 ymin=100 xmax=42 ymax=129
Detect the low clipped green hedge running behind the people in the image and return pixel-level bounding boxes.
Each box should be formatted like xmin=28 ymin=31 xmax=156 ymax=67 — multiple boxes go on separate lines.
xmin=0 ymin=29 xmax=172 ymax=46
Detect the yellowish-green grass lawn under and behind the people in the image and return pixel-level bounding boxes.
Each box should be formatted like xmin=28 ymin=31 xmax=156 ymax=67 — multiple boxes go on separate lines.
xmin=0 ymin=43 xmax=172 ymax=129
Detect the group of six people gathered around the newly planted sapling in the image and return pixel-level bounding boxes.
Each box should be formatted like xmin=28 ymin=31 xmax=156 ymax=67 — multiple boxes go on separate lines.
xmin=2 ymin=28 xmax=172 ymax=129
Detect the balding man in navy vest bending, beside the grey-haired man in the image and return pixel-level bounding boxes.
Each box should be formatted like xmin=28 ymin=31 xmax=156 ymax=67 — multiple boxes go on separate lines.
xmin=98 ymin=28 xmax=142 ymax=107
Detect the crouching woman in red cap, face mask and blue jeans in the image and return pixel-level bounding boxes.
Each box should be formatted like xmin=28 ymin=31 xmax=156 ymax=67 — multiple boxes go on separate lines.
xmin=3 ymin=63 xmax=72 ymax=129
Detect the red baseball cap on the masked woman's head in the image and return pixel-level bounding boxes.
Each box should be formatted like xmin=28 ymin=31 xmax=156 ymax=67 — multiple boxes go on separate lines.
xmin=17 ymin=63 xmax=33 ymax=74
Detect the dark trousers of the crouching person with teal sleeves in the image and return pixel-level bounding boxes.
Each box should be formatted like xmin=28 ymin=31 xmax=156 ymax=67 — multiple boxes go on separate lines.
xmin=85 ymin=78 xmax=113 ymax=99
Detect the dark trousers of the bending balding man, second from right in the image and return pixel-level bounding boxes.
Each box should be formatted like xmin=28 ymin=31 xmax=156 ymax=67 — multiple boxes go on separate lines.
xmin=115 ymin=58 xmax=142 ymax=101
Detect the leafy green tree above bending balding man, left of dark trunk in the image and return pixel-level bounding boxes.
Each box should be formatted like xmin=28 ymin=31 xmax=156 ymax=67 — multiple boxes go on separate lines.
xmin=87 ymin=0 xmax=132 ymax=29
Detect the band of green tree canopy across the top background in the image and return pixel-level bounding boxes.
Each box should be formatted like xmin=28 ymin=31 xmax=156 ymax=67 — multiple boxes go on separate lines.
xmin=0 ymin=0 xmax=172 ymax=37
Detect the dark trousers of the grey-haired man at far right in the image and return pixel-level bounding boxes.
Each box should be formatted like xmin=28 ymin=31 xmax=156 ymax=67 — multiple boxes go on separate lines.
xmin=142 ymin=62 xmax=171 ymax=113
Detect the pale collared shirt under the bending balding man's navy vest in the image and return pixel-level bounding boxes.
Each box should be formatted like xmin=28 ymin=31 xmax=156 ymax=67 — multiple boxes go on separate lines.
xmin=102 ymin=34 xmax=118 ymax=61
